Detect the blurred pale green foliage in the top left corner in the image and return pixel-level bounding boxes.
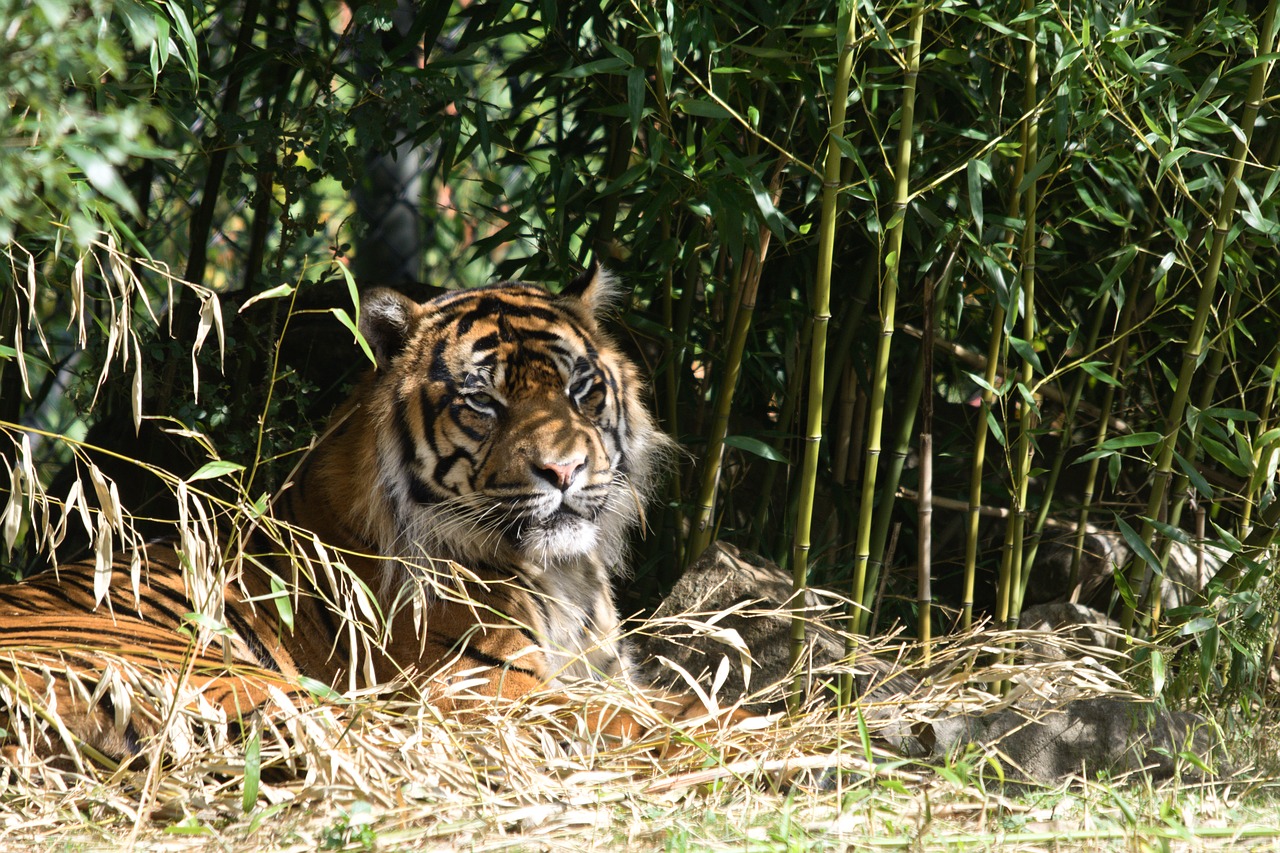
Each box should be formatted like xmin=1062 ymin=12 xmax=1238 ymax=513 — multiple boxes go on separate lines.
xmin=0 ymin=0 xmax=183 ymax=251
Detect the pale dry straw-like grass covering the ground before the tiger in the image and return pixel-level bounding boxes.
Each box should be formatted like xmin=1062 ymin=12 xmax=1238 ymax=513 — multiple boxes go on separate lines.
xmin=0 ymin=617 xmax=1280 ymax=850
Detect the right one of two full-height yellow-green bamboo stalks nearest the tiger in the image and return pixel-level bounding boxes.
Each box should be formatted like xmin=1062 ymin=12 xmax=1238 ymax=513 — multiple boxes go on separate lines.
xmin=842 ymin=5 xmax=924 ymax=655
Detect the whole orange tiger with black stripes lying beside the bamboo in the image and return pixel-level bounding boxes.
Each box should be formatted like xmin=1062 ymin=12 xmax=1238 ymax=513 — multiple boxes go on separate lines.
xmin=0 ymin=266 xmax=696 ymax=760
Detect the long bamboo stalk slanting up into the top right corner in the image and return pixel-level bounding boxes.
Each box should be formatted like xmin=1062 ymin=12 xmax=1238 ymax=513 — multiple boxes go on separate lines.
xmin=1120 ymin=0 xmax=1280 ymax=633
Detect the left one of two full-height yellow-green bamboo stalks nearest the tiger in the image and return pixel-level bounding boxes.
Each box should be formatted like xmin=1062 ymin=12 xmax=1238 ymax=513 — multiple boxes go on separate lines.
xmin=787 ymin=4 xmax=858 ymax=710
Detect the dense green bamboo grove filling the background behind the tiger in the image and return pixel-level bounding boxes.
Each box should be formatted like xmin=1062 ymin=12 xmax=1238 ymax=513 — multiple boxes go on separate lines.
xmin=0 ymin=0 xmax=1280 ymax=695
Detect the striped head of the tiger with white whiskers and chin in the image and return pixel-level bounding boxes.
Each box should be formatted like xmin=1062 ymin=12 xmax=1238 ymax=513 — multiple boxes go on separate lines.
xmin=325 ymin=272 xmax=668 ymax=571
